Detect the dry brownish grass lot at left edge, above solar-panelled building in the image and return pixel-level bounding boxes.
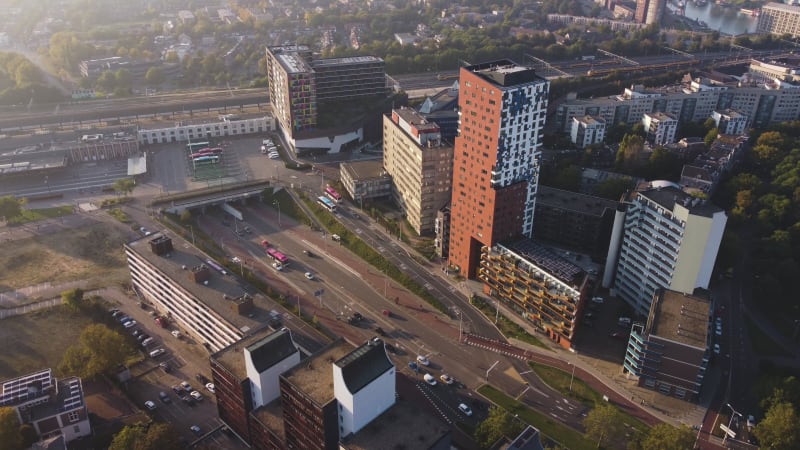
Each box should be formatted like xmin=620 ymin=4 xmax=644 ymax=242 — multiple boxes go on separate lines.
xmin=0 ymin=306 xmax=93 ymax=379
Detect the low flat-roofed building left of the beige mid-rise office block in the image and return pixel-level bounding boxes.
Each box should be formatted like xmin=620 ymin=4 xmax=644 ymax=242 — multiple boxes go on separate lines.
xmin=339 ymin=161 xmax=392 ymax=204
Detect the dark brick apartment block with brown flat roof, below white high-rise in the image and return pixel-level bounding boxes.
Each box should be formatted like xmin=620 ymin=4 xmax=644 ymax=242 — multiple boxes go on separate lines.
xmin=623 ymin=289 xmax=711 ymax=401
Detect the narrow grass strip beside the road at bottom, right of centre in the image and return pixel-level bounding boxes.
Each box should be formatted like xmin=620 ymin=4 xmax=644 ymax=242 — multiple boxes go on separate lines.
xmin=478 ymin=385 xmax=597 ymax=450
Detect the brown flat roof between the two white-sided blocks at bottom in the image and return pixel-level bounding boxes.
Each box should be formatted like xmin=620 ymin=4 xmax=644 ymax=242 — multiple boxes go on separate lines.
xmin=281 ymin=338 xmax=355 ymax=405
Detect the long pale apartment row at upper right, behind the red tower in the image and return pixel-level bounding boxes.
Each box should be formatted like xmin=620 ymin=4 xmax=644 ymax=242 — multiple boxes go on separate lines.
xmin=553 ymin=78 xmax=800 ymax=133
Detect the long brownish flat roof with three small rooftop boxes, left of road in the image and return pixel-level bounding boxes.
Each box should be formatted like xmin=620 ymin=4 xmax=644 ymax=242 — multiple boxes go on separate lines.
xmin=125 ymin=231 xmax=269 ymax=334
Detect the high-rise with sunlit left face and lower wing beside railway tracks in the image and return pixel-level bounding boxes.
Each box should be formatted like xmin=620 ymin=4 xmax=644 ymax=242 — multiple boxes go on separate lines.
xmin=266 ymin=45 xmax=387 ymax=148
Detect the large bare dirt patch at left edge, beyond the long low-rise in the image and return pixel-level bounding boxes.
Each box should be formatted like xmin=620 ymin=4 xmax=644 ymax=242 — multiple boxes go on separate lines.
xmin=0 ymin=221 xmax=130 ymax=291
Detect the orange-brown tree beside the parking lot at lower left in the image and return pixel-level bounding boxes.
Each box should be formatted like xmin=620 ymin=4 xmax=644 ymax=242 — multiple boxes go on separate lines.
xmin=59 ymin=324 xmax=133 ymax=378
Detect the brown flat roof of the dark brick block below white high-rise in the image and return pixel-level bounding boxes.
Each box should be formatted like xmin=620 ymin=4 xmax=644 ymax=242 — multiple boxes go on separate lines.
xmin=648 ymin=289 xmax=711 ymax=349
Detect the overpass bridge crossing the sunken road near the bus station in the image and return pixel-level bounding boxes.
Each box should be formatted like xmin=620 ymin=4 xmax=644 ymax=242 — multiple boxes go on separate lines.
xmin=148 ymin=181 xmax=272 ymax=214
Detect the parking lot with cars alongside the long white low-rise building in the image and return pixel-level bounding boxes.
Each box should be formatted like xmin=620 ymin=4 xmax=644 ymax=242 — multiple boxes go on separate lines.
xmin=109 ymin=292 xmax=245 ymax=449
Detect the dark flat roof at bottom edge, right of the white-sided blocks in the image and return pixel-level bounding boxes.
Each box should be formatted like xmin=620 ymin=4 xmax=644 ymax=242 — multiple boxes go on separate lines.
xmin=342 ymin=396 xmax=450 ymax=450
